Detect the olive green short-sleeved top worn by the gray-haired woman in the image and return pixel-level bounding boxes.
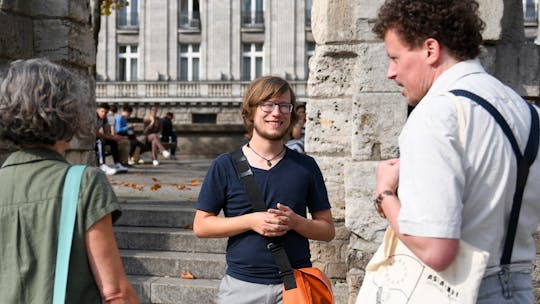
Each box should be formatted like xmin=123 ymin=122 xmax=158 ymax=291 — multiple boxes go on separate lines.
xmin=0 ymin=149 xmax=120 ymax=304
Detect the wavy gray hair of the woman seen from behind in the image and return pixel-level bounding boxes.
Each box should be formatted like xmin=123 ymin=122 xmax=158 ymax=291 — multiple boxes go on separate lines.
xmin=0 ymin=59 xmax=93 ymax=147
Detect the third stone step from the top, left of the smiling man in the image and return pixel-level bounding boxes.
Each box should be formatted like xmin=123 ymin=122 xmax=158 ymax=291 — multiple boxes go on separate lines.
xmin=120 ymin=249 xmax=226 ymax=279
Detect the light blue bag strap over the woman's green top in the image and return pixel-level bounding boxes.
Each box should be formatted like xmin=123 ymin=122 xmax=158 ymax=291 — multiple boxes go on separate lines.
xmin=53 ymin=165 xmax=86 ymax=304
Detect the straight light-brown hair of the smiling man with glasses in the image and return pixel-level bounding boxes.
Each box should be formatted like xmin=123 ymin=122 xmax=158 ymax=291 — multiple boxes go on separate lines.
xmin=242 ymin=76 xmax=298 ymax=138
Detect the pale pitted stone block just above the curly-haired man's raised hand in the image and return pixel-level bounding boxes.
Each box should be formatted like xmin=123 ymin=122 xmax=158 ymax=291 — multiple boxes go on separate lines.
xmin=351 ymin=93 xmax=407 ymax=160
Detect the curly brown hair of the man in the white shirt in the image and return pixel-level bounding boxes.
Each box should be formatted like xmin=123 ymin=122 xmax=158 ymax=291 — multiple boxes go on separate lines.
xmin=373 ymin=0 xmax=485 ymax=60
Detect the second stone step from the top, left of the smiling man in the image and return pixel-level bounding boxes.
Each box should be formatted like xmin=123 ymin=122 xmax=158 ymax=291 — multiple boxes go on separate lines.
xmin=114 ymin=226 xmax=227 ymax=253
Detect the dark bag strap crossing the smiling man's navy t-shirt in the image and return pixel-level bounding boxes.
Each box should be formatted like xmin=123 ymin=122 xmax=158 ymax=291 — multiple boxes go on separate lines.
xmin=230 ymin=148 xmax=296 ymax=290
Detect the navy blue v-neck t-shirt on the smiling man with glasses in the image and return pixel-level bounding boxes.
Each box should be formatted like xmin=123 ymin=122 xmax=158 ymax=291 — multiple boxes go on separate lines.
xmin=197 ymin=148 xmax=330 ymax=284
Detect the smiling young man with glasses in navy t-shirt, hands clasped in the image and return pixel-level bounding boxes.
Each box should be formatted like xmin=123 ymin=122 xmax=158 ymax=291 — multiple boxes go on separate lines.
xmin=193 ymin=77 xmax=335 ymax=304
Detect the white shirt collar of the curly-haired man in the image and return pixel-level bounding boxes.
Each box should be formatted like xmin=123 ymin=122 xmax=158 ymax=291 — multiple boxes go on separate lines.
xmin=422 ymin=59 xmax=486 ymax=100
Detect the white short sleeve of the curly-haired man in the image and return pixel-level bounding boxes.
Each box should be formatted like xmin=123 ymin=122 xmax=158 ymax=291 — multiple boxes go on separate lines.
xmin=398 ymin=96 xmax=465 ymax=238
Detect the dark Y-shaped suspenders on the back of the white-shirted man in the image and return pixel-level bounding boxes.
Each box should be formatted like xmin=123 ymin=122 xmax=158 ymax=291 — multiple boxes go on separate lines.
xmin=450 ymin=90 xmax=539 ymax=265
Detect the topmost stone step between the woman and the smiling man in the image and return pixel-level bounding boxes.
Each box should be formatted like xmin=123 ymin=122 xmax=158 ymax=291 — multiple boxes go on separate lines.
xmin=114 ymin=201 xmax=195 ymax=228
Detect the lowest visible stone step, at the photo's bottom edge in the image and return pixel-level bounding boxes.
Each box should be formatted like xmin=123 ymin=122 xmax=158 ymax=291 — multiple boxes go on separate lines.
xmin=129 ymin=275 xmax=220 ymax=304
